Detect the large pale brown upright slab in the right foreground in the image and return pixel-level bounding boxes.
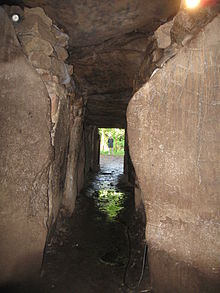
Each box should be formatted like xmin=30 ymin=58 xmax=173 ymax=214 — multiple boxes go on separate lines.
xmin=127 ymin=16 xmax=220 ymax=293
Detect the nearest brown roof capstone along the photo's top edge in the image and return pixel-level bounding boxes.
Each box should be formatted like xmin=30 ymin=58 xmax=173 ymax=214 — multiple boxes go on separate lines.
xmin=18 ymin=0 xmax=180 ymax=47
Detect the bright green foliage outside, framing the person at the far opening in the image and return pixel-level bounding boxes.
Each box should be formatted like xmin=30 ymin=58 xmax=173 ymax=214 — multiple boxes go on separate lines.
xmin=99 ymin=128 xmax=125 ymax=156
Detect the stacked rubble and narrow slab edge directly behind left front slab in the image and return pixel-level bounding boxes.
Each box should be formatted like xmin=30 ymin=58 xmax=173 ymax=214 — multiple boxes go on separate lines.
xmin=8 ymin=7 xmax=74 ymax=227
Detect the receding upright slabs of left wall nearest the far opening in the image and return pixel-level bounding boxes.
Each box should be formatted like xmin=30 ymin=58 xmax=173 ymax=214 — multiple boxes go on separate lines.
xmin=63 ymin=124 xmax=100 ymax=214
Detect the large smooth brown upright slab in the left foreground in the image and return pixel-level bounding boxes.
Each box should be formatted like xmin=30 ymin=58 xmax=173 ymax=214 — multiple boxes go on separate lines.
xmin=0 ymin=8 xmax=51 ymax=283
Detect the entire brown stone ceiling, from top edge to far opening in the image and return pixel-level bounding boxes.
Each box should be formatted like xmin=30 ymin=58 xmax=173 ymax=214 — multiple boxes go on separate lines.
xmin=5 ymin=0 xmax=180 ymax=127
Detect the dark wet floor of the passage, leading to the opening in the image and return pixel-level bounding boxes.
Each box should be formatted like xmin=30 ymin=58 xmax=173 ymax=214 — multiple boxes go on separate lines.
xmin=42 ymin=156 xmax=149 ymax=293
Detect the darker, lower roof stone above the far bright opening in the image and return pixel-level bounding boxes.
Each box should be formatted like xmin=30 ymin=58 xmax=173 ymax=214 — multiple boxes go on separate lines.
xmin=74 ymin=35 xmax=148 ymax=127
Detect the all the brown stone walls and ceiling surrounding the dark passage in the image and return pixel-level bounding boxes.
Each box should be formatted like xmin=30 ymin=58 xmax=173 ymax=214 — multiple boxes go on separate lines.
xmin=0 ymin=0 xmax=220 ymax=293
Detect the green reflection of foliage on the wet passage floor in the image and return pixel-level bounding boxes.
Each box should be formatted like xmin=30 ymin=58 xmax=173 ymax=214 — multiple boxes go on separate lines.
xmin=98 ymin=190 xmax=125 ymax=221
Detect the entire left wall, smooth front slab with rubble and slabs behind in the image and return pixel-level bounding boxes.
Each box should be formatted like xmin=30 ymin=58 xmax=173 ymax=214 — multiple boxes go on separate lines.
xmin=0 ymin=6 xmax=85 ymax=282
